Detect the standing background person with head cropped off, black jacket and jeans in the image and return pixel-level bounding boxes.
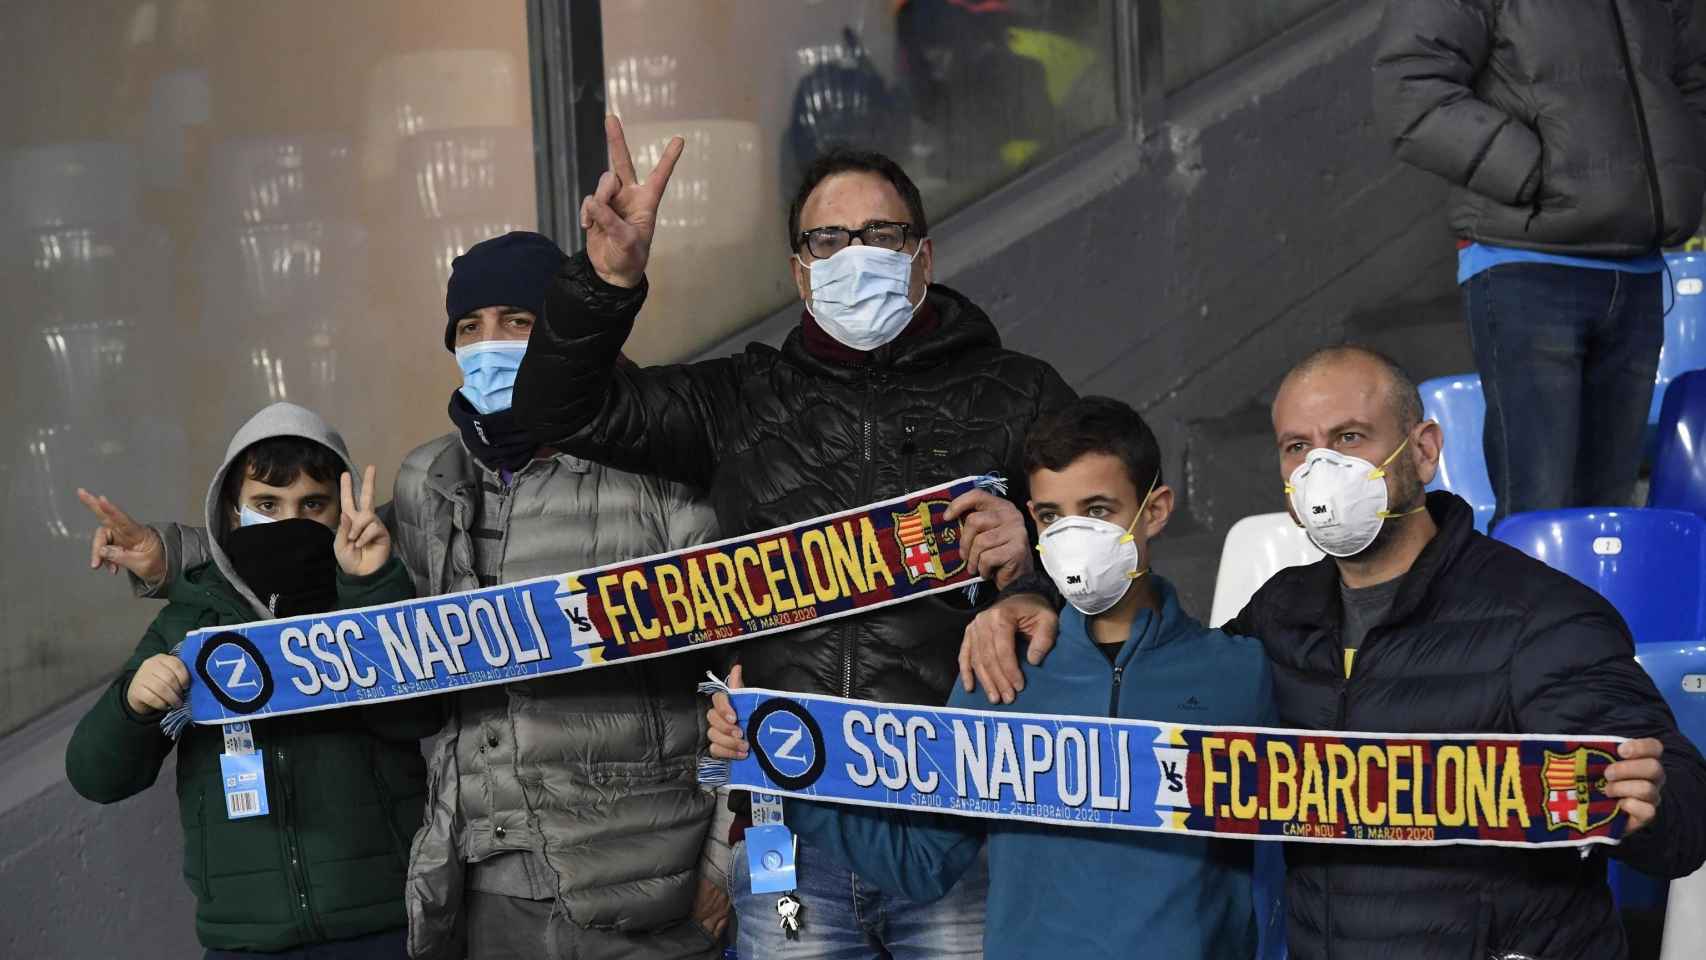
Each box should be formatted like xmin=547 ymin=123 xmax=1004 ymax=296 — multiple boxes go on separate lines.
xmin=1373 ymin=0 xmax=1706 ymax=523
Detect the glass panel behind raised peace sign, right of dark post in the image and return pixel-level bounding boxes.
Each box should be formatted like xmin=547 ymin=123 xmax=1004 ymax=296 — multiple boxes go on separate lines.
xmin=602 ymin=0 xmax=1117 ymax=361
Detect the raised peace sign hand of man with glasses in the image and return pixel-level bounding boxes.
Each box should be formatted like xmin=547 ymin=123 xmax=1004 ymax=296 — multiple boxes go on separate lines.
xmin=580 ymin=116 xmax=688 ymax=288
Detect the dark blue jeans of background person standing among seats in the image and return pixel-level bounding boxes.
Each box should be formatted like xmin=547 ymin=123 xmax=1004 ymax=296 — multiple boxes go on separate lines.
xmin=1464 ymin=263 xmax=1665 ymax=523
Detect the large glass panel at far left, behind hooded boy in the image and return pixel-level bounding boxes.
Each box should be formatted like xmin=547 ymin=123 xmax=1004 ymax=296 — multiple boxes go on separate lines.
xmin=0 ymin=0 xmax=536 ymax=732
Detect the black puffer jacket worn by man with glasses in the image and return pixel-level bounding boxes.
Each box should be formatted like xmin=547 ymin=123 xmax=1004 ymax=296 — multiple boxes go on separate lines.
xmin=515 ymin=254 xmax=1073 ymax=704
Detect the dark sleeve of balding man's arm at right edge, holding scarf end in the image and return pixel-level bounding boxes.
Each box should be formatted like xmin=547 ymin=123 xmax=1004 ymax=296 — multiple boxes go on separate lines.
xmin=1510 ymin=607 xmax=1706 ymax=878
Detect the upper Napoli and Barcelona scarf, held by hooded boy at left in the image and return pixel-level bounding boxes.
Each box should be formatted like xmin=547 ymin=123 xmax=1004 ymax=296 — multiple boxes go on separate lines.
xmin=162 ymin=476 xmax=1005 ymax=735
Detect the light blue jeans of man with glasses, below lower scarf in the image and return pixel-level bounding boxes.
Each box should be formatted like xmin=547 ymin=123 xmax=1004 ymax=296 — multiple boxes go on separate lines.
xmin=728 ymin=841 xmax=989 ymax=960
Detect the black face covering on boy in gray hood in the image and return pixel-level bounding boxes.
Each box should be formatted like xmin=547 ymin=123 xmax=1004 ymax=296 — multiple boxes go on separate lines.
xmin=223 ymin=518 xmax=338 ymax=617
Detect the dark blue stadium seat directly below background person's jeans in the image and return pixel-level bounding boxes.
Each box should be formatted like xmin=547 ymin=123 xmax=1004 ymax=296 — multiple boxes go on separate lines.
xmin=1494 ymin=506 xmax=1706 ymax=646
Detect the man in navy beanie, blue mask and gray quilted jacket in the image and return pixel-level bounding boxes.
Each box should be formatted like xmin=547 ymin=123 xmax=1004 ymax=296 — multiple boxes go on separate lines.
xmin=96 ymin=232 xmax=728 ymax=960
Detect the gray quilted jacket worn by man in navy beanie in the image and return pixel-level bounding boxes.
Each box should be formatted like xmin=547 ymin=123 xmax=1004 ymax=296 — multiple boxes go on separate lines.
xmin=143 ymin=433 xmax=720 ymax=958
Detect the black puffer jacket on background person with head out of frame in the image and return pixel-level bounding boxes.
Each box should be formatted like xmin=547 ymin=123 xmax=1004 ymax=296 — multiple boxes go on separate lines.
xmin=1373 ymin=0 xmax=1706 ymax=257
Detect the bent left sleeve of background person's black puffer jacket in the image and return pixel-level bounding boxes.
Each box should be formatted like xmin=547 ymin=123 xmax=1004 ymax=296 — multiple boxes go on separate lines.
xmin=1373 ymin=0 xmax=1541 ymax=206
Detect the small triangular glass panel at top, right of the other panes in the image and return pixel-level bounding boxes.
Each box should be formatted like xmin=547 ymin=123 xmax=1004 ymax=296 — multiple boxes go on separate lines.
xmin=1162 ymin=0 xmax=1334 ymax=92
